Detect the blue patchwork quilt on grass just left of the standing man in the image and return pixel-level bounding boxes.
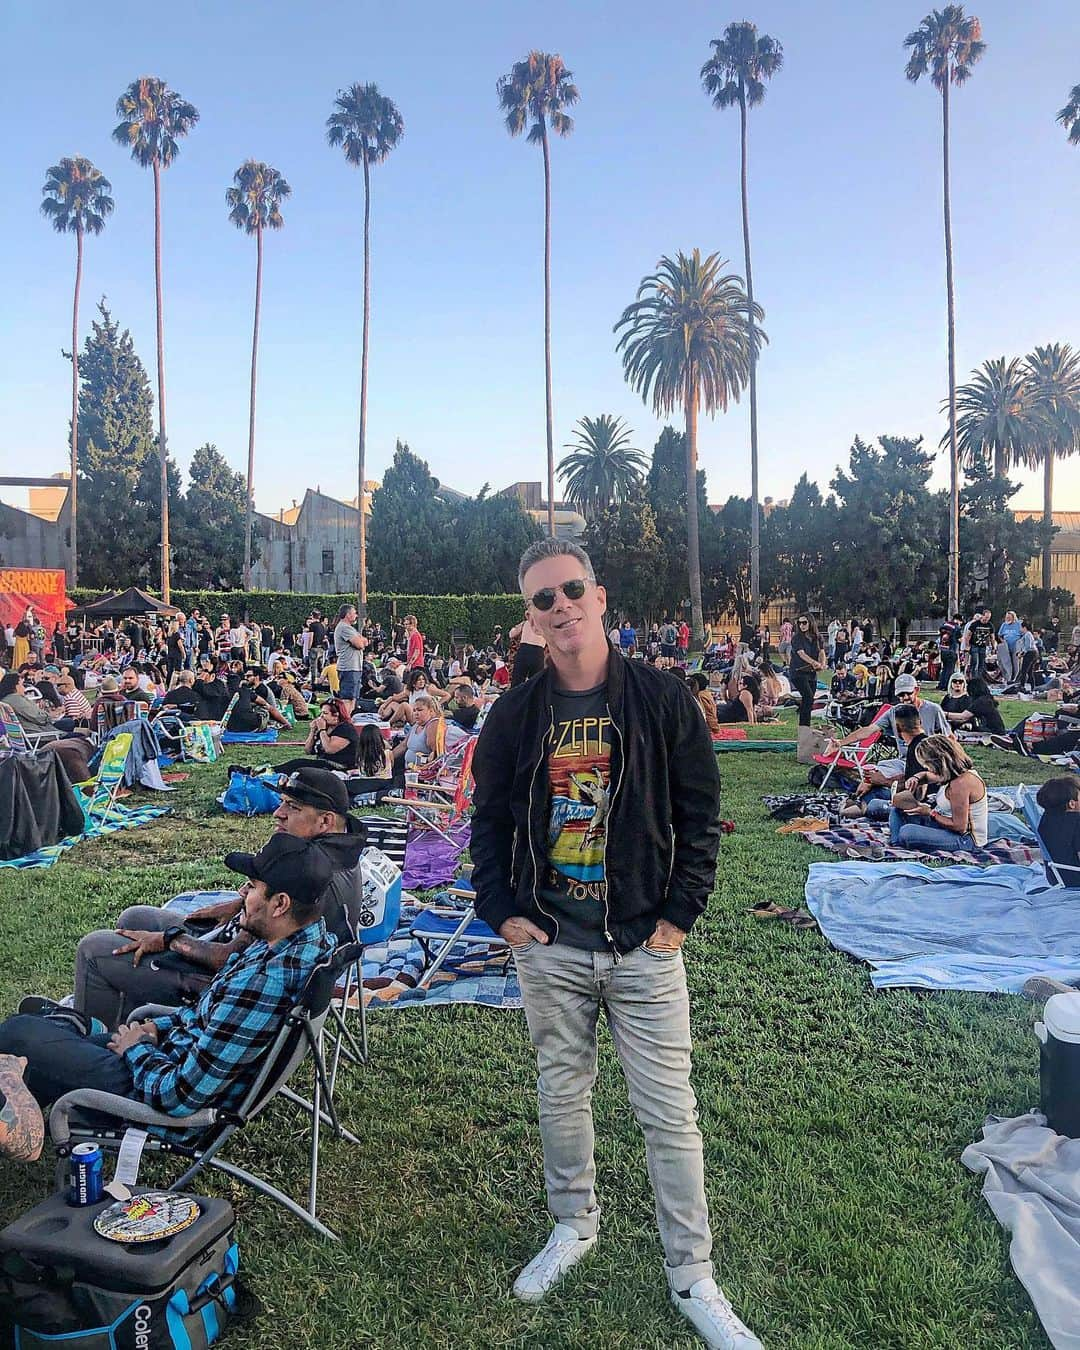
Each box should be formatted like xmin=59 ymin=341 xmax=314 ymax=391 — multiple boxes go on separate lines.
xmin=363 ymin=905 xmax=521 ymax=1010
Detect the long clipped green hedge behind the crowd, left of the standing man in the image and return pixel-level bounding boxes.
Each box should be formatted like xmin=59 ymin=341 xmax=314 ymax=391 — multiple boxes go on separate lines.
xmin=70 ymin=586 xmax=524 ymax=648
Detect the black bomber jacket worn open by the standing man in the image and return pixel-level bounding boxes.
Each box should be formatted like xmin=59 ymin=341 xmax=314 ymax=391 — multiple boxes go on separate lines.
xmin=470 ymin=648 xmax=721 ymax=953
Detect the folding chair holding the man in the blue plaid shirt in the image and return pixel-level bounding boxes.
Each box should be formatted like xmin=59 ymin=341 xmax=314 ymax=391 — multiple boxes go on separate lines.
xmin=49 ymin=944 xmax=360 ymax=1242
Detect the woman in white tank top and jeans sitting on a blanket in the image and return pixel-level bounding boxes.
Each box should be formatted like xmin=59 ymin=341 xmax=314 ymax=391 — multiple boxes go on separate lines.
xmin=888 ymin=736 xmax=990 ymax=853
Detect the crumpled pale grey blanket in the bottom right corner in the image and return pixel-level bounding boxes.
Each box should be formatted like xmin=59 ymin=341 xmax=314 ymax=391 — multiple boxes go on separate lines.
xmin=960 ymin=1111 xmax=1080 ymax=1350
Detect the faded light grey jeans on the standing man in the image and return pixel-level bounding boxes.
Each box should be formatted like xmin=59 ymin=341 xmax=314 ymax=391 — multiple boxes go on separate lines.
xmin=514 ymin=942 xmax=713 ymax=1292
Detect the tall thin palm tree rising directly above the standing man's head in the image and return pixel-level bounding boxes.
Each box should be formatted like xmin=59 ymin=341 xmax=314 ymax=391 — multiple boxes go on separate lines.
xmin=495 ymin=51 xmax=578 ymax=537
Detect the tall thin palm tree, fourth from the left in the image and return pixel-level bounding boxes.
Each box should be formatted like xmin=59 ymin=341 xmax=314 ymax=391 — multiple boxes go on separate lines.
xmin=327 ymin=84 xmax=405 ymax=621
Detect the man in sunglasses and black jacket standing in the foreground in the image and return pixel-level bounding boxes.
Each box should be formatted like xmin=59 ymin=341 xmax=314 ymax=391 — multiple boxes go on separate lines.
xmin=471 ymin=539 xmax=760 ymax=1350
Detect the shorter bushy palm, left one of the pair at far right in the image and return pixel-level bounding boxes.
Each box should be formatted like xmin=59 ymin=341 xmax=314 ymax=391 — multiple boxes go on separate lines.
xmin=941 ymin=356 xmax=1035 ymax=478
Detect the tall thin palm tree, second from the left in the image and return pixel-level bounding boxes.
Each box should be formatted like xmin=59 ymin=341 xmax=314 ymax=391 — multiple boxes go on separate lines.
xmin=112 ymin=76 xmax=198 ymax=603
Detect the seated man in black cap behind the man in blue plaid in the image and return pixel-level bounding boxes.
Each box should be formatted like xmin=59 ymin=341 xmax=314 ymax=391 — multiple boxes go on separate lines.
xmin=70 ymin=768 xmax=367 ymax=1026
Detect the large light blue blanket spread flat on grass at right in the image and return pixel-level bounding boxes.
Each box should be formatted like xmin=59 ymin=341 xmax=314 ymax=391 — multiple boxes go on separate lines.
xmin=805 ymin=863 xmax=1080 ymax=994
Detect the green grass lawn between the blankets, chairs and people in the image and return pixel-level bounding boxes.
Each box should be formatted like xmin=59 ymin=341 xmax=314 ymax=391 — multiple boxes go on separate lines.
xmin=0 ymin=703 xmax=1049 ymax=1350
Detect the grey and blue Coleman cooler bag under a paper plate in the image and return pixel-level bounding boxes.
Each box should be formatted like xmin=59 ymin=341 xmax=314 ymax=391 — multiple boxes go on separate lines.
xmin=0 ymin=1187 xmax=239 ymax=1350
